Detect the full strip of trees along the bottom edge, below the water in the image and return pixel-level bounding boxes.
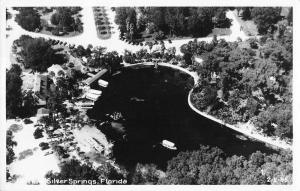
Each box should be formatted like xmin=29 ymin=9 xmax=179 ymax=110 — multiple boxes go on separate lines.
xmin=46 ymin=145 xmax=293 ymax=185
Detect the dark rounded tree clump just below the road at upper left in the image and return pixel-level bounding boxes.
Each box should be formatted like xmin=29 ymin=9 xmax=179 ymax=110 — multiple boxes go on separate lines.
xmin=15 ymin=35 xmax=66 ymax=72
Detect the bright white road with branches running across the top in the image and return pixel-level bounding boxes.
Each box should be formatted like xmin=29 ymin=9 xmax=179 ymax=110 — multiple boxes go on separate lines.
xmin=7 ymin=7 xmax=248 ymax=62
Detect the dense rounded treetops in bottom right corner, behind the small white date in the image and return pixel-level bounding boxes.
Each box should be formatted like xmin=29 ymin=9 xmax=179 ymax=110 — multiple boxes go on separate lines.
xmin=158 ymin=146 xmax=293 ymax=184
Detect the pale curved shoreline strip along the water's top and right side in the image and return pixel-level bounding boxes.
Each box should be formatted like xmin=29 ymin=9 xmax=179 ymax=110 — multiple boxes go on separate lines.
xmin=124 ymin=62 xmax=293 ymax=150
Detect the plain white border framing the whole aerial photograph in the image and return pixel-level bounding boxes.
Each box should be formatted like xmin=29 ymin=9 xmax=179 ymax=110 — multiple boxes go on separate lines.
xmin=0 ymin=0 xmax=300 ymax=191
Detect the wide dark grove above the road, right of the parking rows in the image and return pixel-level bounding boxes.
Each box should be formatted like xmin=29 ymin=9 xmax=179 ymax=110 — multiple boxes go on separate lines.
xmin=115 ymin=7 xmax=231 ymax=40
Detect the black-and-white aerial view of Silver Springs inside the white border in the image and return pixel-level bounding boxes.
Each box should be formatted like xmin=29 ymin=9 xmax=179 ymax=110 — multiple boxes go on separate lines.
xmin=0 ymin=6 xmax=293 ymax=187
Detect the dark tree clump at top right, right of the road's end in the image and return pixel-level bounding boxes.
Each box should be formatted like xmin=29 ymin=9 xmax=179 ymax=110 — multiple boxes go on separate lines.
xmin=241 ymin=7 xmax=286 ymax=34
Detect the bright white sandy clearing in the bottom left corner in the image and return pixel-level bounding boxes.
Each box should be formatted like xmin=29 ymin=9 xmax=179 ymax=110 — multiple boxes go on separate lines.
xmin=6 ymin=117 xmax=59 ymax=184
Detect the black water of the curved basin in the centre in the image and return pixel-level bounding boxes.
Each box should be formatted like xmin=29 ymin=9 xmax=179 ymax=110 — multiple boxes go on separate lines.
xmin=88 ymin=66 xmax=275 ymax=169
